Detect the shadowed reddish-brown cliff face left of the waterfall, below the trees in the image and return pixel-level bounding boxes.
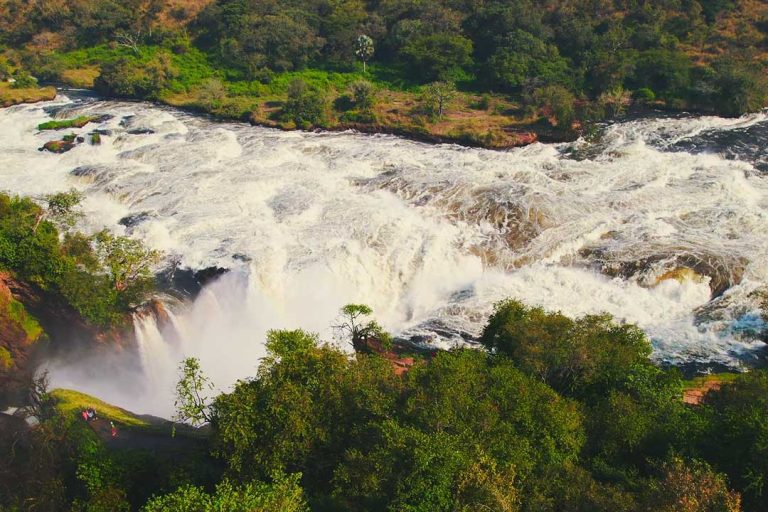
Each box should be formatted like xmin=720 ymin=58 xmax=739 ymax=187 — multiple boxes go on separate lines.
xmin=0 ymin=272 xmax=133 ymax=409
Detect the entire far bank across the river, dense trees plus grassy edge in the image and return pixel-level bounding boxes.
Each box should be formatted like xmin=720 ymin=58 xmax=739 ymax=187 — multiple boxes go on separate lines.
xmin=0 ymin=0 xmax=768 ymax=146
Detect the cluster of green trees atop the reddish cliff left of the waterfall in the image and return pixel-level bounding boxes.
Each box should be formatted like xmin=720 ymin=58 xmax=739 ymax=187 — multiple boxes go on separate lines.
xmin=0 ymin=192 xmax=158 ymax=330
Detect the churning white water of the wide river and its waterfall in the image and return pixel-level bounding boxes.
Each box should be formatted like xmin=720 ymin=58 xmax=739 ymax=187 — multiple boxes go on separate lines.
xmin=0 ymin=97 xmax=768 ymax=413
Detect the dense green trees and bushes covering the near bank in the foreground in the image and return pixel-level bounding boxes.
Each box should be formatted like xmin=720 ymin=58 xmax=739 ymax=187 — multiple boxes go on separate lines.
xmin=0 ymin=301 xmax=768 ymax=512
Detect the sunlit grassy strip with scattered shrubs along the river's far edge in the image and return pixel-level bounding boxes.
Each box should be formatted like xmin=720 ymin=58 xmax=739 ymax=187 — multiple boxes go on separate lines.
xmin=40 ymin=47 xmax=581 ymax=150
